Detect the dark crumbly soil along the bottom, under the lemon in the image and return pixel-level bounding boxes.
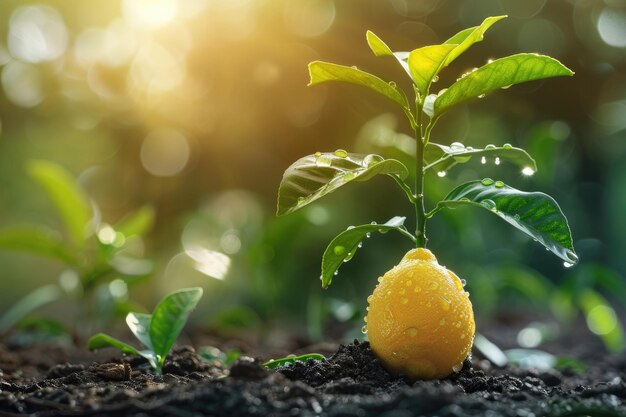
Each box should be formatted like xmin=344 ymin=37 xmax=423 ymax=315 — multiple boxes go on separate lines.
xmin=0 ymin=341 xmax=626 ymax=417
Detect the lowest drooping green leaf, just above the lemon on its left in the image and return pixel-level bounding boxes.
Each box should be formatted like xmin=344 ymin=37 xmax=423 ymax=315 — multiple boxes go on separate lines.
xmin=320 ymin=216 xmax=414 ymax=288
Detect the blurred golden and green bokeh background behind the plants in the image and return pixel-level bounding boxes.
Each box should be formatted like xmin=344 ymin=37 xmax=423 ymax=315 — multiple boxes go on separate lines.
xmin=0 ymin=0 xmax=626 ymax=345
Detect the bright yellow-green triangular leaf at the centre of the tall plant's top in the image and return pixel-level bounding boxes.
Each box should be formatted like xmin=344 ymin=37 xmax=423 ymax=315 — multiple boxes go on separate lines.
xmin=409 ymin=45 xmax=456 ymax=96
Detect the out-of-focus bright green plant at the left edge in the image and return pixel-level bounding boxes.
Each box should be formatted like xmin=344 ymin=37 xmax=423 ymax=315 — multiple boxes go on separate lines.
xmin=0 ymin=160 xmax=154 ymax=333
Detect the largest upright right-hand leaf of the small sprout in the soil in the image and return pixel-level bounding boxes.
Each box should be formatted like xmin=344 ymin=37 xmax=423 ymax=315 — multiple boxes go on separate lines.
xmin=150 ymin=287 xmax=202 ymax=365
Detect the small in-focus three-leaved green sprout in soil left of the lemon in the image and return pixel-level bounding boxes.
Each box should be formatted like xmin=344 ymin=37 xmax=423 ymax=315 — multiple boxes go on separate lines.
xmin=87 ymin=288 xmax=202 ymax=374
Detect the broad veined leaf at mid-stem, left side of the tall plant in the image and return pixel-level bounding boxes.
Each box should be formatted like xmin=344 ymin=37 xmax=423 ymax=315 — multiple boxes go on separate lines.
xmin=276 ymin=150 xmax=408 ymax=216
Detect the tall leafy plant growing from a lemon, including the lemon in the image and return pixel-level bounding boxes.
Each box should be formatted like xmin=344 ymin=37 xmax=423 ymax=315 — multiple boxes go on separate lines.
xmin=277 ymin=16 xmax=578 ymax=378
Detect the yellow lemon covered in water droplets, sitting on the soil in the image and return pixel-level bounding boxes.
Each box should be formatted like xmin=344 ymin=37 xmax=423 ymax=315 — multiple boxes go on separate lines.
xmin=364 ymin=248 xmax=476 ymax=379
